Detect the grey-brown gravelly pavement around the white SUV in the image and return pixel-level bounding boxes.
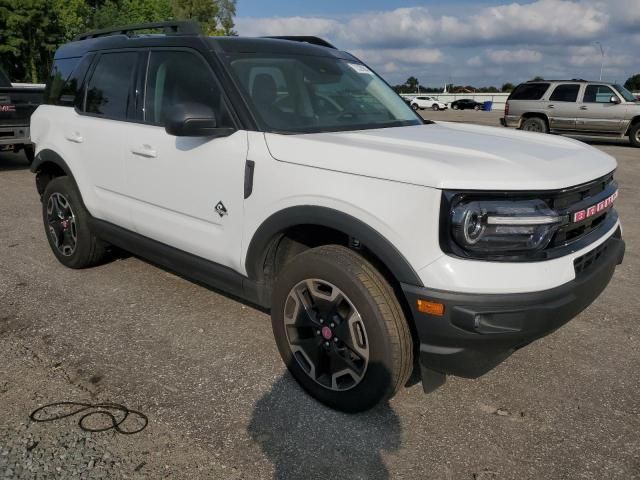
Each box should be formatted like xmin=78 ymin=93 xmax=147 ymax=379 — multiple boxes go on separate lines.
xmin=0 ymin=117 xmax=640 ymax=480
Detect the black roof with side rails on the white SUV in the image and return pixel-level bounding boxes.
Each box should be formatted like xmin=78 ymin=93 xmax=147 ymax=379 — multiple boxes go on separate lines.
xmin=55 ymin=22 xmax=355 ymax=60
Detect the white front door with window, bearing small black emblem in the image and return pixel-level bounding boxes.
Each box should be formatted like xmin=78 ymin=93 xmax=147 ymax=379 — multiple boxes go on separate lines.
xmin=126 ymin=50 xmax=248 ymax=270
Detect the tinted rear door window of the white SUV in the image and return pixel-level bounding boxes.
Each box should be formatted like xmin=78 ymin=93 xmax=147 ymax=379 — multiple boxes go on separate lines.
xmin=86 ymin=52 xmax=138 ymax=120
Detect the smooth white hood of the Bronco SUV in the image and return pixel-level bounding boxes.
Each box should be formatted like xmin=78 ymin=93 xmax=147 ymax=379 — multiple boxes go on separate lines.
xmin=265 ymin=122 xmax=616 ymax=190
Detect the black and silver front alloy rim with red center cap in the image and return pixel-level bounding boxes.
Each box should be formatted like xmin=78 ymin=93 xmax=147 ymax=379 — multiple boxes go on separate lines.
xmin=284 ymin=279 xmax=369 ymax=391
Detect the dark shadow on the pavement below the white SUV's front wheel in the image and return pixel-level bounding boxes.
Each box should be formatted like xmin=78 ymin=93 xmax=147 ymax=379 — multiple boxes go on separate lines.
xmin=248 ymin=373 xmax=402 ymax=480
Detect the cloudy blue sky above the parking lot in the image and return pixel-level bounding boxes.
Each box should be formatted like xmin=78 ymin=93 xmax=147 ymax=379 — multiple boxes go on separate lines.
xmin=236 ymin=0 xmax=640 ymax=87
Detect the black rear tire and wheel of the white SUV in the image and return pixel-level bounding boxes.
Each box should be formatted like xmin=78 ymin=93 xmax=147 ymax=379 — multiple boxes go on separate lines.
xmin=42 ymin=177 xmax=107 ymax=268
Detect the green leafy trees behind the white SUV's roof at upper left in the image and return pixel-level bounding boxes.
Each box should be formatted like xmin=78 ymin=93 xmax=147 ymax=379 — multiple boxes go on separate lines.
xmin=0 ymin=0 xmax=236 ymax=83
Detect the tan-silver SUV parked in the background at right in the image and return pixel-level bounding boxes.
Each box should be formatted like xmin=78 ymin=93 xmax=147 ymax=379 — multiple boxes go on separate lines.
xmin=500 ymin=80 xmax=640 ymax=147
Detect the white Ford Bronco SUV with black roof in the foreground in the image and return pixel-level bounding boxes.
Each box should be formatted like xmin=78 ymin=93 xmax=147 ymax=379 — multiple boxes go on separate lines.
xmin=31 ymin=23 xmax=624 ymax=412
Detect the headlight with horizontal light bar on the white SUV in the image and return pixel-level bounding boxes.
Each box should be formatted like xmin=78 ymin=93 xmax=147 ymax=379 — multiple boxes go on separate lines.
xmin=443 ymin=199 xmax=567 ymax=258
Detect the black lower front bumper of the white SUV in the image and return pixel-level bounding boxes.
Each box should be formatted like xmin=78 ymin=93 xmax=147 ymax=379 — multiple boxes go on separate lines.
xmin=402 ymin=230 xmax=625 ymax=390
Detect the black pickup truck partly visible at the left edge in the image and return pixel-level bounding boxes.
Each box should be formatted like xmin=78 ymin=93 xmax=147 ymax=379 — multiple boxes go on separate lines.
xmin=0 ymin=68 xmax=44 ymax=163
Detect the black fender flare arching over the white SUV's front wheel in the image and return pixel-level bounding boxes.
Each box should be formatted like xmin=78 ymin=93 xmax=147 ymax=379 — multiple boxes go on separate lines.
xmin=245 ymin=205 xmax=423 ymax=287
